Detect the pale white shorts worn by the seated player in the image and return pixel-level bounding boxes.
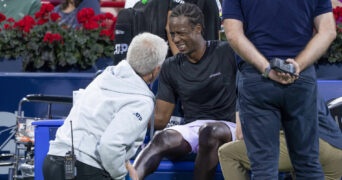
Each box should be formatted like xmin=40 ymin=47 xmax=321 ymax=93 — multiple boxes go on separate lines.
xmin=166 ymin=120 xmax=236 ymax=153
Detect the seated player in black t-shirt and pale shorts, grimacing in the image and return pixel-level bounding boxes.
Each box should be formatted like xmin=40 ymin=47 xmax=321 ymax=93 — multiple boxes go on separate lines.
xmin=133 ymin=3 xmax=236 ymax=179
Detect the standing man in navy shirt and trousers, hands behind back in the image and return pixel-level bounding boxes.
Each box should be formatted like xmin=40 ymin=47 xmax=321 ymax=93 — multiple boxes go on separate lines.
xmin=222 ymin=0 xmax=336 ymax=180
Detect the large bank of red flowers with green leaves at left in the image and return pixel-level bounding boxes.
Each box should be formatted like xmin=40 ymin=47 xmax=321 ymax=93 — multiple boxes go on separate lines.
xmin=0 ymin=4 xmax=116 ymax=71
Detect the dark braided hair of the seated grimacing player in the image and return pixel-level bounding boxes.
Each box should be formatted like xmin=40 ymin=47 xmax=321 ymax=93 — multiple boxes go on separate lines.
xmin=170 ymin=3 xmax=205 ymax=30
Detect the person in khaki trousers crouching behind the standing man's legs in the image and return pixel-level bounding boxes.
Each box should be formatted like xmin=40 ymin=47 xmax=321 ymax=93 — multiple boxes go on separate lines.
xmin=218 ymin=98 xmax=342 ymax=180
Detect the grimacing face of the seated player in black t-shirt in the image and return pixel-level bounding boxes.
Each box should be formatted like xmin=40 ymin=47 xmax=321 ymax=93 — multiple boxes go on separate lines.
xmin=169 ymin=16 xmax=201 ymax=54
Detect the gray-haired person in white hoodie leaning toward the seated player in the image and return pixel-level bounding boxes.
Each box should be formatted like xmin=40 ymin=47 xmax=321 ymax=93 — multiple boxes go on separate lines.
xmin=43 ymin=33 xmax=168 ymax=180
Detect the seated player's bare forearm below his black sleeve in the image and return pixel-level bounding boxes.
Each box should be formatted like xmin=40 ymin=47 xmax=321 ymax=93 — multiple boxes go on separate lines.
xmin=154 ymin=99 xmax=175 ymax=130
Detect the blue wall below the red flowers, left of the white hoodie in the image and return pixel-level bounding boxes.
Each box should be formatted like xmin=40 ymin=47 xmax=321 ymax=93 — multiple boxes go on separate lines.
xmin=0 ymin=73 xmax=94 ymax=117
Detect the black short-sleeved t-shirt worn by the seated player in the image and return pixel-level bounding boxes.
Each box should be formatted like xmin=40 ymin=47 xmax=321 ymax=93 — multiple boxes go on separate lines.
xmin=157 ymin=41 xmax=236 ymax=123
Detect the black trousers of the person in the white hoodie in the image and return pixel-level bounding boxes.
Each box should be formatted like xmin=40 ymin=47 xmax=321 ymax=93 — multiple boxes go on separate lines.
xmin=43 ymin=155 xmax=112 ymax=180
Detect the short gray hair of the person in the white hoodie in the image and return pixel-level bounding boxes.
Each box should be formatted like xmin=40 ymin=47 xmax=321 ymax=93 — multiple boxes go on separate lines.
xmin=127 ymin=32 xmax=168 ymax=76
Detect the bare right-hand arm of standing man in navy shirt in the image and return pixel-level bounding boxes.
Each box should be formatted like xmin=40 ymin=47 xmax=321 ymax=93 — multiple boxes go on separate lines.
xmin=296 ymin=12 xmax=336 ymax=70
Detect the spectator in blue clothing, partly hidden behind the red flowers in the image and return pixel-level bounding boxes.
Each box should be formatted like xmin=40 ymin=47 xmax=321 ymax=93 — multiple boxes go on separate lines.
xmin=54 ymin=0 xmax=101 ymax=28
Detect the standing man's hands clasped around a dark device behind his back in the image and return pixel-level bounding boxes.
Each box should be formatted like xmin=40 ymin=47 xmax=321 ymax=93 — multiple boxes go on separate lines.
xmin=268 ymin=58 xmax=300 ymax=84
